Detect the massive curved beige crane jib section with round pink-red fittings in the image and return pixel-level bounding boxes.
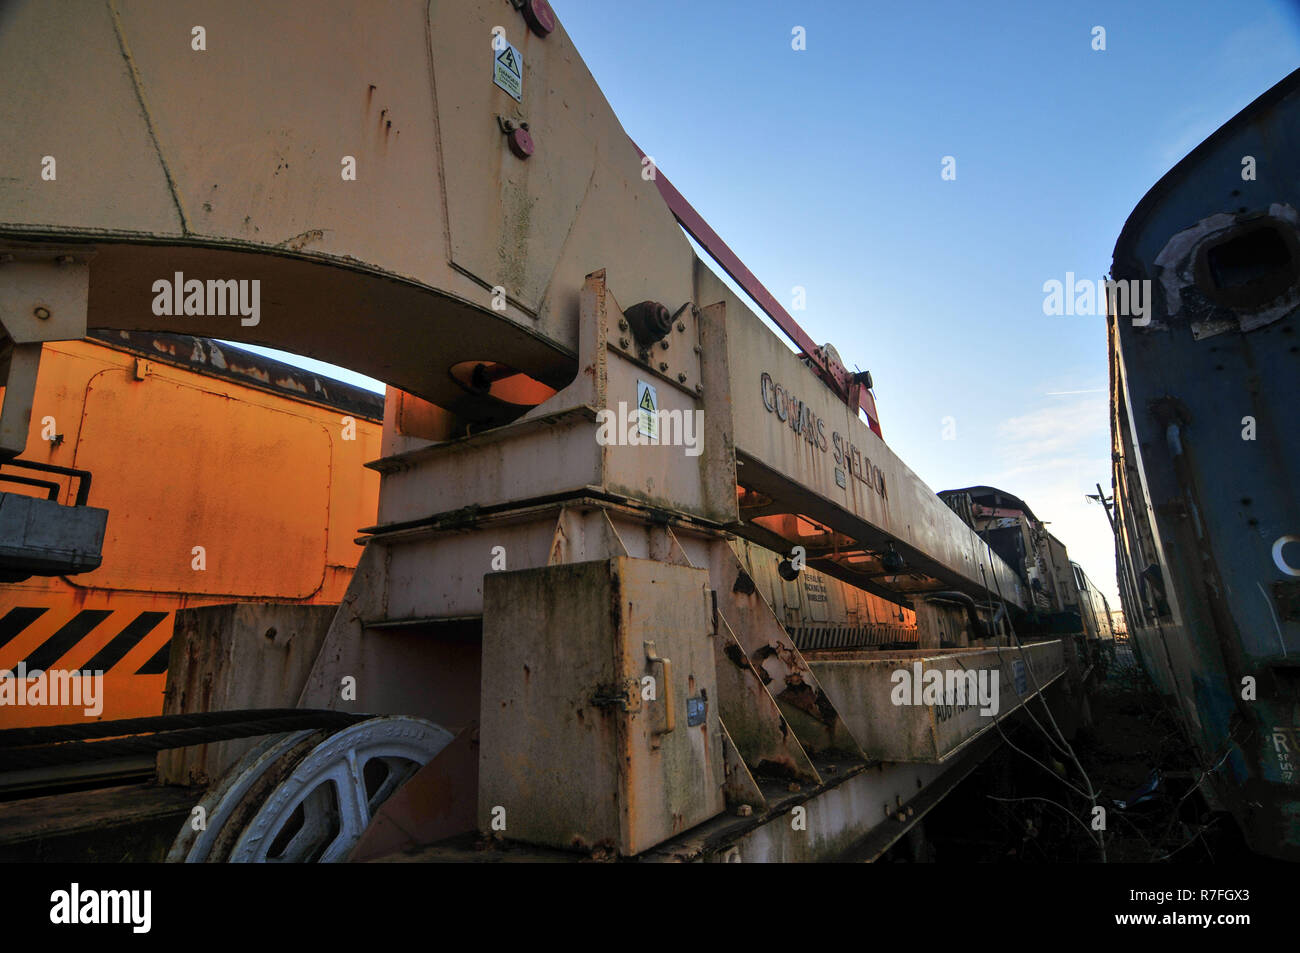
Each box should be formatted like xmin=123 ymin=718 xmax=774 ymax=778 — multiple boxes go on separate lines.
xmin=0 ymin=0 xmax=692 ymax=406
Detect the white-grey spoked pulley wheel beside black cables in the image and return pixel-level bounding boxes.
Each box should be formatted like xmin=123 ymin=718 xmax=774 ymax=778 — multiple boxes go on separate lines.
xmin=168 ymin=715 xmax=452 ymax=863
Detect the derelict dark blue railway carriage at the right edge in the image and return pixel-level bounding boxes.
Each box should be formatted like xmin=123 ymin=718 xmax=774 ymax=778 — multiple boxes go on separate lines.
xmin=1109 ymin=72 xmax=1300 ymax=859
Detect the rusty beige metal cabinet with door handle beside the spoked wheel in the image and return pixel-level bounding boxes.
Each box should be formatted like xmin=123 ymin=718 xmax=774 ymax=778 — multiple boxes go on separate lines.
xmin=478 ymin=558 xmax=725 ymax=855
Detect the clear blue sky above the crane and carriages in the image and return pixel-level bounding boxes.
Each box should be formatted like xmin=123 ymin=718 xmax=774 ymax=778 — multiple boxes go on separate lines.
xmin=236 ymin=0 xmax=1300 ymax=608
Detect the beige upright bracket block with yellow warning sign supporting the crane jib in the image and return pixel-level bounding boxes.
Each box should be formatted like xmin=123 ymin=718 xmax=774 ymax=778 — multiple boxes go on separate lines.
xmin=373 ymin=270 xmax=736 ymax=529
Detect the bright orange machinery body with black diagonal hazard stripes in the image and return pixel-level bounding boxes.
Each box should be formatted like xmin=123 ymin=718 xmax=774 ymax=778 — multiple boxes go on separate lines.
xmin=0 ymin=330 xmax=384 ymax=728
